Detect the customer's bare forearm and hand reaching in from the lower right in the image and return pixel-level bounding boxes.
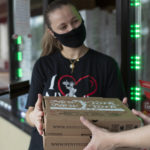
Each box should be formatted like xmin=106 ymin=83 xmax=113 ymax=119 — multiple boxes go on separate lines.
xmin=80 ymin=117 xmax=150 ymax=150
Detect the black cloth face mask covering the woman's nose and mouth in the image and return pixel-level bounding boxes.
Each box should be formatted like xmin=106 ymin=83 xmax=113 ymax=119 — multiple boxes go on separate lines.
xmin=53 ymin=21 xmax=86 ymax=48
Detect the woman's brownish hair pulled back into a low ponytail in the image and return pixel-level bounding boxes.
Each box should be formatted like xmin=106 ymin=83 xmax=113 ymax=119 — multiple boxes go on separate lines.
xmin=41 ymin=0 xmax=75 ymax=56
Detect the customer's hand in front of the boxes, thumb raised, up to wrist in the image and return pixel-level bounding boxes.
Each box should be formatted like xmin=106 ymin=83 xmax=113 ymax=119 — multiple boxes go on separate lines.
xmin=80 ymin=117 xmax=115 ymax=150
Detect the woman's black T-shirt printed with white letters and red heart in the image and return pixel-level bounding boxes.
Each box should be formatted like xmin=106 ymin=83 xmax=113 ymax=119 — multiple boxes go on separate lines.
xmin=26 ymin=49 xmax=125 ymax=150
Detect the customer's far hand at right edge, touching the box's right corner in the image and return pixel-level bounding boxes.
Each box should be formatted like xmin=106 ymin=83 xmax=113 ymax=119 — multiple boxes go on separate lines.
xmin=132 ymin=109 xmax=150 ymax=125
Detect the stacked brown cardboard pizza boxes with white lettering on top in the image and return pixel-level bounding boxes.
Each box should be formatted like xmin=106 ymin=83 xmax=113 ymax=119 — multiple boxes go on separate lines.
xmin=42 ymin=97 xmax=141 ymax=150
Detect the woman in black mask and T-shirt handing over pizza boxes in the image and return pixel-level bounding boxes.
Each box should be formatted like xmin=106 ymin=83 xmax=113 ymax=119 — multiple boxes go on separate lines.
xmin=26 ymin=0 xmax=126 ymax=150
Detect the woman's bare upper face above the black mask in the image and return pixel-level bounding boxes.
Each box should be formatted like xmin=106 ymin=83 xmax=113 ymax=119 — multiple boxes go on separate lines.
xmin=49 ymin=5 xmax=82 ymax=34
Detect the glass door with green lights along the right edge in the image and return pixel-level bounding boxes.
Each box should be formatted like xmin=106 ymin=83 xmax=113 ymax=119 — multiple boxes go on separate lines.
xmin=128 ymin=0 xmax=150 ymax=114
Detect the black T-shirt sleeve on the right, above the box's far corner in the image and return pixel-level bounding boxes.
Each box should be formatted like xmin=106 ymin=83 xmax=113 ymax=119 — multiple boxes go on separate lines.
xmin=104 ymin=58 xmax=126 ymax=100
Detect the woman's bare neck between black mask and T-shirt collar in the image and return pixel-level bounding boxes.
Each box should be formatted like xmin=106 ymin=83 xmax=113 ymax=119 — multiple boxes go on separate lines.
xmin=61 ymin=45 xmax=89 ymax=59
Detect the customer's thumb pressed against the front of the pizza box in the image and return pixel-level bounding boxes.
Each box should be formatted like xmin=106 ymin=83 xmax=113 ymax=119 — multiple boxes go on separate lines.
xmin=80 ymin=116 xmax=97 ymax=133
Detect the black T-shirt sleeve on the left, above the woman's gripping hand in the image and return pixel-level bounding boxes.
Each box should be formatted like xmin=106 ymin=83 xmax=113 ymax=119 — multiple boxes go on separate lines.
xmin=26 ymin=59 xmax=45 ymax=109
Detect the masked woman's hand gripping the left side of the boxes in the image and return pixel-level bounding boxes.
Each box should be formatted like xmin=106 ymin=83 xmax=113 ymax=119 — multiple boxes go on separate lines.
xmin=29 ymin=94 xmax=44 ymax=135
